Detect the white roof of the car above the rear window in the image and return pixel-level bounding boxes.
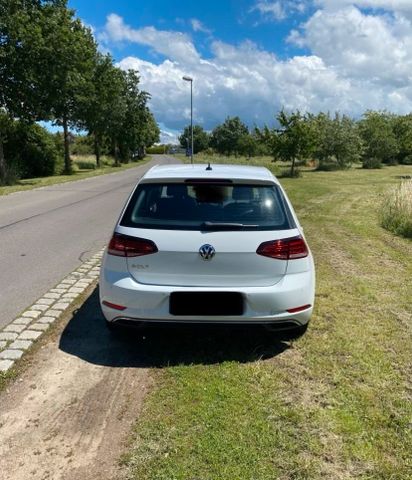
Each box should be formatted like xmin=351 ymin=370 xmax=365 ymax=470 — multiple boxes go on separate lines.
xmin=142 ymin=164 xmax=279 ymax=184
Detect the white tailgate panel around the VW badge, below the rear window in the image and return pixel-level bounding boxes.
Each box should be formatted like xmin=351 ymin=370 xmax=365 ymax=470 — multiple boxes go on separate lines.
xmin=116 ymin=227 xmax=299 ymax=287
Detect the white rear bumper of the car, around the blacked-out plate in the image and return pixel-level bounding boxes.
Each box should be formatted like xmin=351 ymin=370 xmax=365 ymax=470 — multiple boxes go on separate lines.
xmin=100 ymin=258 xmax=315 ymax=326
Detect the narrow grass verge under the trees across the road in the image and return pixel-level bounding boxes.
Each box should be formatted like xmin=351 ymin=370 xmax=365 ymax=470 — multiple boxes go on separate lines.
xmin=0 ymin=155 xmax=151 ymax=196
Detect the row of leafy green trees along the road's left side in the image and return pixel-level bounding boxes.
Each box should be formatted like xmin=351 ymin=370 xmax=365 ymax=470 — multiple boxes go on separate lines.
xmin=0 ymin=0 xmax=159 ymax=182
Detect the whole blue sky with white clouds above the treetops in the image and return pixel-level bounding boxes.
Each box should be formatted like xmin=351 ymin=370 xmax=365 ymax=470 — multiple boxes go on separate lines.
xmin=69 ymin=0 xmax=412 ymax=141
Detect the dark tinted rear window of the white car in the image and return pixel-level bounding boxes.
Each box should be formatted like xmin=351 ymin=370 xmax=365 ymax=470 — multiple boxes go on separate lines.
xmin=120 ymin=182 xmax=295 ymax=230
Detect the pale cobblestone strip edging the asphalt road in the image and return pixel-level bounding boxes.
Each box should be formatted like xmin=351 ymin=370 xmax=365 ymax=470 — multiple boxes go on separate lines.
xmin=0 ymin=250 xmax=103 ymax=372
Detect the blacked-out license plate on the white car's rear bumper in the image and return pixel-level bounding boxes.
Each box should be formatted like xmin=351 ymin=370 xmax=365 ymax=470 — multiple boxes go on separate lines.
xmin=169 ymin=292 xmax=244 ymax=316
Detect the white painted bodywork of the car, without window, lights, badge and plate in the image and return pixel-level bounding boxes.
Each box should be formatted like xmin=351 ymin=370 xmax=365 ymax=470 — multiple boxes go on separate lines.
xmin=100 ymin=165 xmax=315 ymax=326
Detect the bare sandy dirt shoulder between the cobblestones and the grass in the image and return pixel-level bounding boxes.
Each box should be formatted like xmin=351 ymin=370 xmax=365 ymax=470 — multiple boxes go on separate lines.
xmin=0 ymin=288 xmax=150 ymax=480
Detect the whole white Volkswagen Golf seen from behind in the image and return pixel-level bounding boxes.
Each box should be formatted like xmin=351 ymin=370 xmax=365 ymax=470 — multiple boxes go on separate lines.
xmin=100 ymin=165 xmax=315 ymax=335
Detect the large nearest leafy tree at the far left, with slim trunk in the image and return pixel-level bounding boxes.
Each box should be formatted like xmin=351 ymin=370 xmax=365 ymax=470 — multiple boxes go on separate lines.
xmin=0 ymin=0 xmax=96 ymax=175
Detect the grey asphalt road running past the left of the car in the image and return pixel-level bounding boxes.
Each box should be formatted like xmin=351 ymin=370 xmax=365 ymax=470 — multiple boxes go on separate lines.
xmin=0 ymin=155 xmax=176 ymax=328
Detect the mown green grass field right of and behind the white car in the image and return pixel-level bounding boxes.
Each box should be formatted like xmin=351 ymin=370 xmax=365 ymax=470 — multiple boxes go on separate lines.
xmin=123 ymin=159 xmax=412 ymax=480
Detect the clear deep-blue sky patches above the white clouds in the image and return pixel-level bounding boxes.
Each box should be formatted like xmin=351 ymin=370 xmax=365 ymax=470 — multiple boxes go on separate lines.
xmin=69 ymin=0 xmax=309 ymax=61
